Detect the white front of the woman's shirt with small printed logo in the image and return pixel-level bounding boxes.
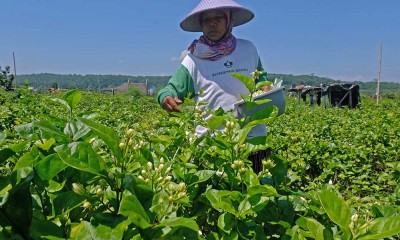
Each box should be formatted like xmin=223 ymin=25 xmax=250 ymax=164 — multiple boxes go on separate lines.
xmin=182 ymin=39 xmax=267 ymax=138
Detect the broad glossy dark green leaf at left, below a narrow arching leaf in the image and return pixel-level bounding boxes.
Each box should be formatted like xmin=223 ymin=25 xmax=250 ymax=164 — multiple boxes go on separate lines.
xmin=54 ymin=142 xmax=106 ymax=175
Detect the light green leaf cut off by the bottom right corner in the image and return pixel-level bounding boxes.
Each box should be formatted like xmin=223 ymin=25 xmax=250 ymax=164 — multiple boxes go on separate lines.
xmin=357 ymin=216 xmax=400 ymax=240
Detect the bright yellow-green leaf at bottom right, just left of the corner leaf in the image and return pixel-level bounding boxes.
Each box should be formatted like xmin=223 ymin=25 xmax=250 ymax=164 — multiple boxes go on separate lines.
xmin=317 ymin=190 xmax=351 ymax=238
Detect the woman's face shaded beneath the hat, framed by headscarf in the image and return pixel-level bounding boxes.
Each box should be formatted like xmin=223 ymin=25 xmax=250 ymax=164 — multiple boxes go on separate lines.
xmin=201 ymin=10 xmax=226 ymax=42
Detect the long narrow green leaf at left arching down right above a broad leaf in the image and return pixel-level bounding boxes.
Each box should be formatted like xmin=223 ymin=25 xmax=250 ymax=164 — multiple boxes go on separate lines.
xmin=77 ymin=117 xmax=122 ymax=160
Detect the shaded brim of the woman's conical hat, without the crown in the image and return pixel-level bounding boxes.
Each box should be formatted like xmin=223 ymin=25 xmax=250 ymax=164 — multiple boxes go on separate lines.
xmin=180 ymin=7 xmax=254 ymax=32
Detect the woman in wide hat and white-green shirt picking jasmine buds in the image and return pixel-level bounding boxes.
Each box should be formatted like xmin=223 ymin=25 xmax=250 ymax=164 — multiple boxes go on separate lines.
xmin=158 ymin=0 xmax=267 ymax=172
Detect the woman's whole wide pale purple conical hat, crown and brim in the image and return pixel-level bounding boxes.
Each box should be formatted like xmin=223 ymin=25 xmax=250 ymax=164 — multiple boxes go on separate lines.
xmin=180 ymin=0 xmax=254 ymax=32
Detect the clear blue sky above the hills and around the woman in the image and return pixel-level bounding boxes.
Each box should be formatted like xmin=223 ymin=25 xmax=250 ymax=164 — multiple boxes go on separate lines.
xmin=0 ymin=0 xmax=400 ymax=82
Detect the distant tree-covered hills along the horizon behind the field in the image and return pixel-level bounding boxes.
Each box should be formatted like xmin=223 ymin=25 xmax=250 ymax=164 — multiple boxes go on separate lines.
xmin=17 ymin=73 xmax=400 ymax=95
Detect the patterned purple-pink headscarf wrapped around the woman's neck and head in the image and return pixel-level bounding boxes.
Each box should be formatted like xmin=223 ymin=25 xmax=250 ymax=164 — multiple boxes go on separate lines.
xmin=188 ymin=9 xmax=236 ymax=61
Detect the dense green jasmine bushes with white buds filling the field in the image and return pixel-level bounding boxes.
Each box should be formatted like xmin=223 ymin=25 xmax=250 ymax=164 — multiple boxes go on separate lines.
xmin=0 ymin=90 xmax=400 ymax=239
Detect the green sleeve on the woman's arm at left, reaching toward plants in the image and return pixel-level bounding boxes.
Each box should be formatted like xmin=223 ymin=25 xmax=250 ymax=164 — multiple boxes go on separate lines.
xmin=157 ymin=64 xmax=195 ymax=104
